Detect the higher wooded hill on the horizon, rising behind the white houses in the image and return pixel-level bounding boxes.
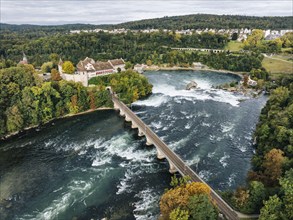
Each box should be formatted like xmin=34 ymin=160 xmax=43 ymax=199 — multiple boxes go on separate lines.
xmin=103 ymin=14 xmax=293 ymax=30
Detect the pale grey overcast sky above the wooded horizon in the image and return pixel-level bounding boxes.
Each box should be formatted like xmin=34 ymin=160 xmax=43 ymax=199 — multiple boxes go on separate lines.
xmin=0 ymin=0 xmax=293 ymax=24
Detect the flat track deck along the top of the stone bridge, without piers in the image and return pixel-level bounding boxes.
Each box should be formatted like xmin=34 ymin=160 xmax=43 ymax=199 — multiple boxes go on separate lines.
xmin=112 ymin=95 xmax=239 ymax=219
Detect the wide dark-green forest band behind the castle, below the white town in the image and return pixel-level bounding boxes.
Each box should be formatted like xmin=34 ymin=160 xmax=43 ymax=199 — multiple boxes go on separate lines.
xmin=0 ymin=29 xmax=263 ymax=71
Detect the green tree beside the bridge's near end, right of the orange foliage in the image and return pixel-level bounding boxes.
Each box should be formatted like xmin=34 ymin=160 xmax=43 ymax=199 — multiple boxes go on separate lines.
xmin=187 ymin=194 xmax=218 ymax=220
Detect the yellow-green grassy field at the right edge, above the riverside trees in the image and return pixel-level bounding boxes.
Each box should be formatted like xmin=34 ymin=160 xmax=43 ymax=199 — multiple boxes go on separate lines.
xmin=262 ymin=57 xmax=293 ymax=74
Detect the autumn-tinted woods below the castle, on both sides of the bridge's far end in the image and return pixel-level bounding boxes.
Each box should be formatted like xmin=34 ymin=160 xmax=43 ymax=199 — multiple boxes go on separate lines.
xmin=0 ymin=64 xmax=152 ymax=138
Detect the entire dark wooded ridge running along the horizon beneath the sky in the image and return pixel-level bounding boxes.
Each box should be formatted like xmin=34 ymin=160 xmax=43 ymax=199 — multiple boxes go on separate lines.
xmin=0 ymin=14 xmax=293 ymax=33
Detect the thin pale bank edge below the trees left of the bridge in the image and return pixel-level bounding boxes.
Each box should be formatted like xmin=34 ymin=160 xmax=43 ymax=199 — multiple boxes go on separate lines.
xmin=0 ymin=107 xmax=113 ymax=141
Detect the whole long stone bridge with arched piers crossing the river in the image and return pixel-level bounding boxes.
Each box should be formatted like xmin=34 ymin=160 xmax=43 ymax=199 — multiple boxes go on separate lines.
xmin=110 ymin=89 xmax=257 ymax=220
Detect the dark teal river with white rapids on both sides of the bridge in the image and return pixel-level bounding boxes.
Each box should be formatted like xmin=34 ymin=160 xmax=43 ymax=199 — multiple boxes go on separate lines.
xmin=0 ymin=71 xmax=267 ymax=220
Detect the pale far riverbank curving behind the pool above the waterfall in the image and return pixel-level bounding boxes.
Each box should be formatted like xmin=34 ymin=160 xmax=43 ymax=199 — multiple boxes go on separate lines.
xmin=144 ymin=65 xmax=243 ymax=78
